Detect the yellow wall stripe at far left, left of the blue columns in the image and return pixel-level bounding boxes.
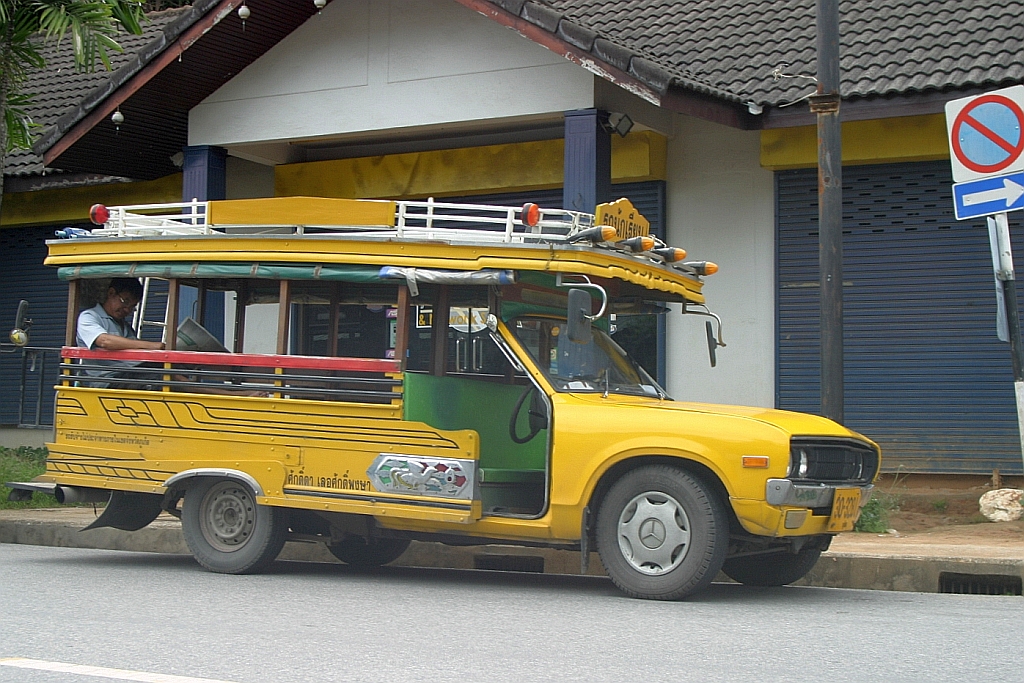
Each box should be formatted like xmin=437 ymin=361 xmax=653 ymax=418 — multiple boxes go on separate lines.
xmin=0 ymin=173 xmax=181 ymax=227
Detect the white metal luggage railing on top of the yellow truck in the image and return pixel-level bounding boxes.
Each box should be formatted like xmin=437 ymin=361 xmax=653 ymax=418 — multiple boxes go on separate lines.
xmin=74 ymin=199 xmax=594 ymax=244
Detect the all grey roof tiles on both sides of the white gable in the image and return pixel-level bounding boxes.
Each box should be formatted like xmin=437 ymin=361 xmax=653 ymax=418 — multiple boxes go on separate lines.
xmin=4 ymin=0 xmax=1024 ymax=175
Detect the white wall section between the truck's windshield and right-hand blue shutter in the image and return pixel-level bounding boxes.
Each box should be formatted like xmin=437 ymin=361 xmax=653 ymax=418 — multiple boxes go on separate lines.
xmin=667 ymin=116 xmax=775 ymax=408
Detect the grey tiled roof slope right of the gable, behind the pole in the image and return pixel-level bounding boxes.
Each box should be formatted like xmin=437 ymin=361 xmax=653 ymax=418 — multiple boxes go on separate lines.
xmin=490 ymin=0 xmax=1024 ymax=106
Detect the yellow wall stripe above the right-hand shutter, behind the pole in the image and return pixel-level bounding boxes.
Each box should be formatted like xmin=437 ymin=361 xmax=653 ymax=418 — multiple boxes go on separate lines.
xmin=761 ymin=114 xmax=949 ymax=171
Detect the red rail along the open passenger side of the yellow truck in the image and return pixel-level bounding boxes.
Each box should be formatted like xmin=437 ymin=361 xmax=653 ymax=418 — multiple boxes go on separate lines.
xmin=60 ymin=346 xmax=401 ymax=373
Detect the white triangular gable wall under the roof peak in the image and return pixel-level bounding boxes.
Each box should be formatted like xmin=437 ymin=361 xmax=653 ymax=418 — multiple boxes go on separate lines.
xmin=188 ymin=0 xmax=594 ymax=146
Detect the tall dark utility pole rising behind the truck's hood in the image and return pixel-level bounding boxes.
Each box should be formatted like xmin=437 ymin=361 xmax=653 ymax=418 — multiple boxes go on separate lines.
xmin=810 ymin=0 xmax=844 ymax=424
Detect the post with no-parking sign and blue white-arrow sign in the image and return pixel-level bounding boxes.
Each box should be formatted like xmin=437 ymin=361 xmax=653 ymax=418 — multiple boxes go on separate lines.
xmin=946 ymin=85 xmax=1024 ymax=475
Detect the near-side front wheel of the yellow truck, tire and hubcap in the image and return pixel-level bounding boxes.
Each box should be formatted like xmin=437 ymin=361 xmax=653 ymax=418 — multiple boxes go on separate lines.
xmin=597 ymin=465 xmax=729 ymax=600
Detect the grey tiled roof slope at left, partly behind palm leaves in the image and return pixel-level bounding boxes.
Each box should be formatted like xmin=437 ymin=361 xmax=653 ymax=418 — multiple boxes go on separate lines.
xmin=3 ymin=9 xmax=186 ymax=176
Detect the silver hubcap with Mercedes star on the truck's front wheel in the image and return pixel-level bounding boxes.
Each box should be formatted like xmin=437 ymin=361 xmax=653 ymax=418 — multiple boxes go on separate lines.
xmin=618 ymin=490 xmax=690 ymax=575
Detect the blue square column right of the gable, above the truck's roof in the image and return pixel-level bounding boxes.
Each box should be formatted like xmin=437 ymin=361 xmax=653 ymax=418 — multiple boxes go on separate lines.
xmin=562 ymin=110 xmax=611 ymax=213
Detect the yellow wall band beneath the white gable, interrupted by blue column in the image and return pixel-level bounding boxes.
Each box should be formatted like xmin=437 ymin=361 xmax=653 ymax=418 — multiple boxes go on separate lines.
xmin=274 ymin=131 xmax=668 ymax=199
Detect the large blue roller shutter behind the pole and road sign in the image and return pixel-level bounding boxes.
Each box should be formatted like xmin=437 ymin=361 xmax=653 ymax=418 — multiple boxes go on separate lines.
xmin=775 ymin=162 xmax=1024 ymax=474
